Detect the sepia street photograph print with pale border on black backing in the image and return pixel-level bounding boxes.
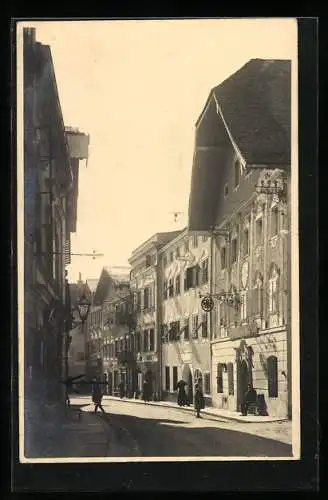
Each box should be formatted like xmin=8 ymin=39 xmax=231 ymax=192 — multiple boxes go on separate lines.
xmin=17 ymin=18 xmax=301 ymax=463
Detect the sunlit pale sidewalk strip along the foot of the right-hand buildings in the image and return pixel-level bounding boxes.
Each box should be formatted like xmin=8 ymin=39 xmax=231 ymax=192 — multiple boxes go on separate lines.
xmin=104 ymin=396 xmax=288 ymax=424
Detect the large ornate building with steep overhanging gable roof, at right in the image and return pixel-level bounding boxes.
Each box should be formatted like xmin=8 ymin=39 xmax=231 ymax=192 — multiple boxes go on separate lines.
xmin=189 ymin=60 xmax=291 ymax=418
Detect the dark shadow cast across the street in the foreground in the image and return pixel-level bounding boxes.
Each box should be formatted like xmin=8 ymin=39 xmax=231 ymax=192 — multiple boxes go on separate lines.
xmin=102 ymin=412 xmax=292 ymax=458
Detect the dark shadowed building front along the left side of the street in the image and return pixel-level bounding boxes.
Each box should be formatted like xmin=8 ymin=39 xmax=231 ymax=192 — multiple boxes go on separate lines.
xmin=24 ymin=28 xmax=88 ymax=426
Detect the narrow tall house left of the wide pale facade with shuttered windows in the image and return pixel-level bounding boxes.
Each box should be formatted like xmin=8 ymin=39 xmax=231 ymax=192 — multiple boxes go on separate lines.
xmin=129 ymin=231 xmax=179 ymax=399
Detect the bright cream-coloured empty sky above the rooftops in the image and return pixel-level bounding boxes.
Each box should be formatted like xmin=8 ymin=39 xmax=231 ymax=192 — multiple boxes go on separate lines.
xmin=24 ymin=19 xmax=297 ymax=281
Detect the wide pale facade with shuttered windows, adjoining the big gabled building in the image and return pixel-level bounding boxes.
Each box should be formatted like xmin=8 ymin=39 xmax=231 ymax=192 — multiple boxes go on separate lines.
xmin=159 ymin=229 xmax=211 ymax=404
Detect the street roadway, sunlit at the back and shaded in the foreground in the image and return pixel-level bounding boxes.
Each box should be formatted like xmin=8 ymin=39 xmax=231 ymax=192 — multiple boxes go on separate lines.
xmin=73 ymin=397 xmax=292 ymax=457
